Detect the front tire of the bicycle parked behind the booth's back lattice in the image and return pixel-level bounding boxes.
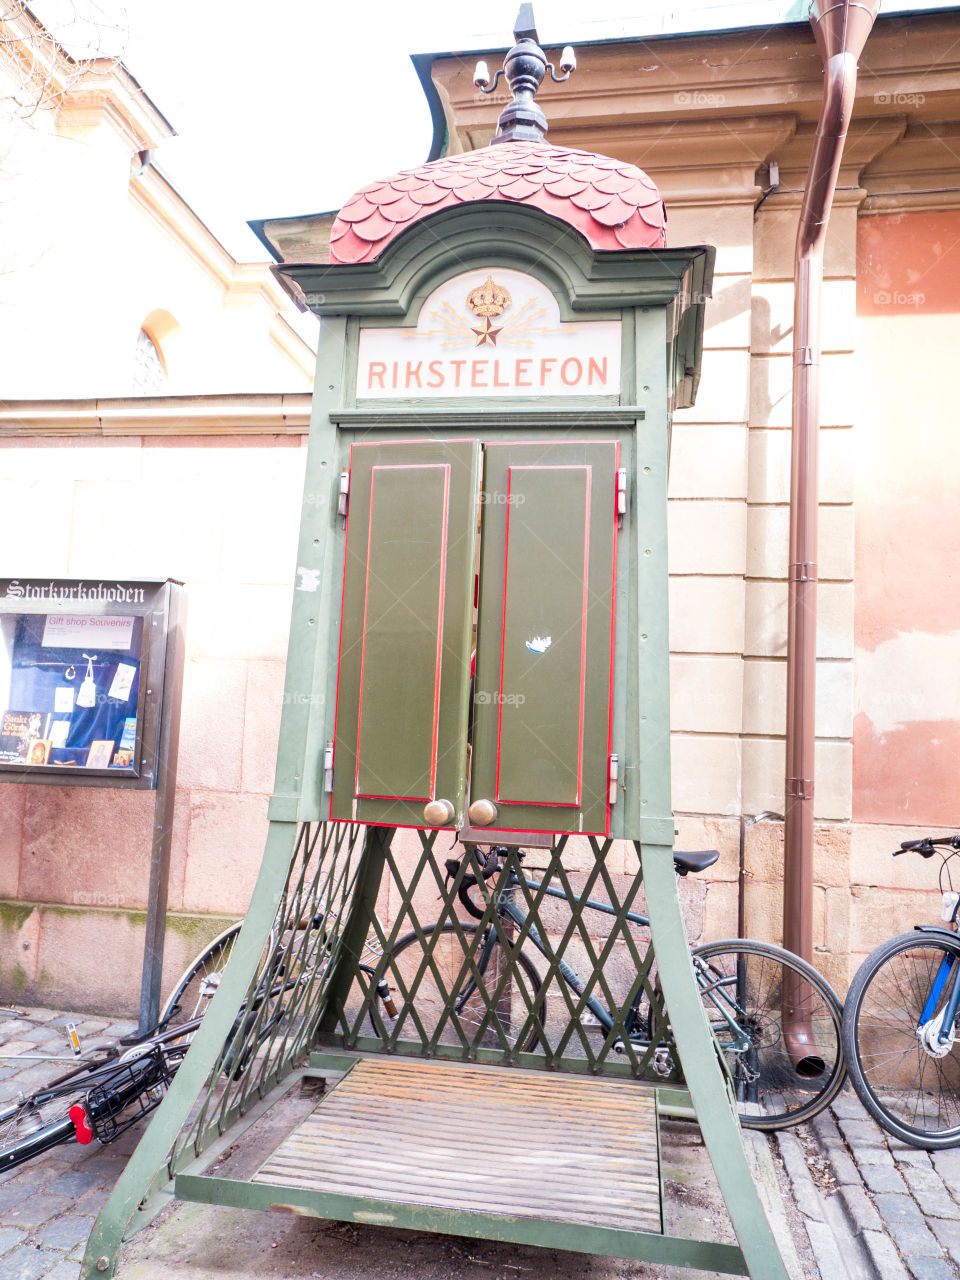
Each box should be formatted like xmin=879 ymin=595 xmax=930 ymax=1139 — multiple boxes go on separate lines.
xmin=381 ymin=922 xmax=547 ymax=1052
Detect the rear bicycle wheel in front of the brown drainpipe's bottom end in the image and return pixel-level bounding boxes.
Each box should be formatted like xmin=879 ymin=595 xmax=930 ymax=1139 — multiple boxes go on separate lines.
xmin=691 ymin=938 xmax=846 ymax=1129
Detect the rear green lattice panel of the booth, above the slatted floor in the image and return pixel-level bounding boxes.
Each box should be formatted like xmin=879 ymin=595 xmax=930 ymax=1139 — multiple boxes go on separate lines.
xmin=321 ymin=832 xmax=676 ymax=1080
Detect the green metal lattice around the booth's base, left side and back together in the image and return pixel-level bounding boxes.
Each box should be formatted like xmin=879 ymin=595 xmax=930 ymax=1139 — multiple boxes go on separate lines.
xmin=163 ymin=823 xmax=677 ymax=1171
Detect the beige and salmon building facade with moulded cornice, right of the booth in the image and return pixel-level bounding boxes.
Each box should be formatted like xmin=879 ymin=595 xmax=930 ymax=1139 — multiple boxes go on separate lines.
xmin=431 ymin=12 xmax=960 ymax=991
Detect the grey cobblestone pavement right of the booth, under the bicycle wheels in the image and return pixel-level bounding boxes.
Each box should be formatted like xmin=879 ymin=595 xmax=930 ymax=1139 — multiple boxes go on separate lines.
xmin=773 ymin=1084 xmax=960 ymax=1280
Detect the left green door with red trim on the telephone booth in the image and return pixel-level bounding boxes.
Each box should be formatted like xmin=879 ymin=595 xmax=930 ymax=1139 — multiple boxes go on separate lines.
xmin=330 ymin=440 xmax=480 ymax=827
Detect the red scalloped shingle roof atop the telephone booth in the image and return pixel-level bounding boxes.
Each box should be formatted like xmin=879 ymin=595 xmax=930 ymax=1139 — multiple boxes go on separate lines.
xmin=330 ymin=142 xmax=667 ymax=262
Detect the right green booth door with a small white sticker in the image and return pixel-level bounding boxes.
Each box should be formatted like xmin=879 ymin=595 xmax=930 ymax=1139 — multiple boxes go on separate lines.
xmin=470 ymin=440 xmax=618 ymax=835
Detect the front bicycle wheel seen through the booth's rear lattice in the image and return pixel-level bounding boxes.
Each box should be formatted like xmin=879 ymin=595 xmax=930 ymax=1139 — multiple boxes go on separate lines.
xmin=384 ymin=922 xmax=547 ymax=1050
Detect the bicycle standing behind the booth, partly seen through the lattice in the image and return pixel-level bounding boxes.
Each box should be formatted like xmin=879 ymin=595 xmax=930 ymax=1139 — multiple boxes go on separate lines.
xmin=378 ymin=846 xmax=845 ymax=1129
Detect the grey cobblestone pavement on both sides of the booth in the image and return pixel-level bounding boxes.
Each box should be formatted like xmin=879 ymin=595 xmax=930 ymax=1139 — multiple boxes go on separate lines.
xmin=9 ymin=1009 xmax=960 ymax=1280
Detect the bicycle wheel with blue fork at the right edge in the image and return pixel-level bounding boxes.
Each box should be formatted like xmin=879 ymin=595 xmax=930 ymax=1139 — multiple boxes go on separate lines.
xmin=844 ymin=933 xmax=960 ymax=1149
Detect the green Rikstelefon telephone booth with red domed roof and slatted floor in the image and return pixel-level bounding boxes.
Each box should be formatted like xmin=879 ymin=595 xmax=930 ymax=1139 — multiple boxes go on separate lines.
xmin=84 ymin=17 xmax=786 ymax=1280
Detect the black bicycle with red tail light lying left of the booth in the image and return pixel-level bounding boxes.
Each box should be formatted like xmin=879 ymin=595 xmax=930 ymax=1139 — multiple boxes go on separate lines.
xmin=0 ymin=914 xmax=393 ymax=1172
